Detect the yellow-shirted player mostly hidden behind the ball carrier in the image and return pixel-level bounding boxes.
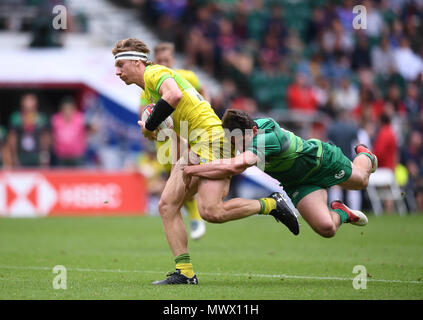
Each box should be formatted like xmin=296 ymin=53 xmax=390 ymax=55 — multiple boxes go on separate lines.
xmin=140 ymin=42 xmax=208 ymax=240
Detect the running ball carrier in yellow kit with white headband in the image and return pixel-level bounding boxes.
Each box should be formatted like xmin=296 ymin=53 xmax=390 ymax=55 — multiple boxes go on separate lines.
xmin=112 ymin=38 xmax=299 ymax=284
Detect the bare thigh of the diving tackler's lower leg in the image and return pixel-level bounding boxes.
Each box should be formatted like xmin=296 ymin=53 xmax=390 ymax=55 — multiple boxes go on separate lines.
xmin=297 ymin=189 xmax=333 ymax=233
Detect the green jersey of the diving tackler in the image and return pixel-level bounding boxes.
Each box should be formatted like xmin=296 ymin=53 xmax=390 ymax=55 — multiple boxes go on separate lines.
xmin=248 ymin=118 xmax=322 ymax=186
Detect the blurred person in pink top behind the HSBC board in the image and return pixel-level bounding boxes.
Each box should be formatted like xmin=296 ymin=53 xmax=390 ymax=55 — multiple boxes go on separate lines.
xmin=51 ymin=98 xmax=87 ymax=167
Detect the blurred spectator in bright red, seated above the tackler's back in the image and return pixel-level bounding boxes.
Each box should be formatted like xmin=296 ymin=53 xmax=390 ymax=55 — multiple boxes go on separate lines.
xmin=287 ymin=73 xmax=317 ymax=113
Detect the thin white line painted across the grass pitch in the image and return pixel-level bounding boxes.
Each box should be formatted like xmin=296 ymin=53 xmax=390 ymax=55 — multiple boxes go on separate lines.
xmin=0 ymin=265 xmax=423 ymax=284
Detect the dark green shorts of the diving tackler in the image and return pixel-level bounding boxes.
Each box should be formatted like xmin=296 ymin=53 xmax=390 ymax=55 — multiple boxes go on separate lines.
xmin=283 ymin=142 xmax=352 ymax=207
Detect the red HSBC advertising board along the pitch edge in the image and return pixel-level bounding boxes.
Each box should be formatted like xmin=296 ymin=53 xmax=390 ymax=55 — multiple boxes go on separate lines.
xmin=0 ymin=170 xmax=148 ymax=217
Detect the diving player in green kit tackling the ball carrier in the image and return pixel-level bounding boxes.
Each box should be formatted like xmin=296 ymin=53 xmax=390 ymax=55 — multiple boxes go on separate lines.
xmin=183 ymin=109 xmax=377 ymax=237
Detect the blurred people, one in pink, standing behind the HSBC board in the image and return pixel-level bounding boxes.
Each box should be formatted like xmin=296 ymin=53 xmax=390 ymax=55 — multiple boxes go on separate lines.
xmin=0 ymin=93 xmax=90 ymax=168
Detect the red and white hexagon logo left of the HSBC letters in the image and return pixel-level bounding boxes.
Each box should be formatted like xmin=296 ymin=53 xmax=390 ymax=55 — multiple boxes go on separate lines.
xmin=0 ymin=172 xmax=57 ymax=217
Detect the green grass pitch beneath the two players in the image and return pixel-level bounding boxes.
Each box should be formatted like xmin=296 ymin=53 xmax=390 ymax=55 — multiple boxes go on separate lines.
xmin=0 ymin=215 xmax=423 ymax=300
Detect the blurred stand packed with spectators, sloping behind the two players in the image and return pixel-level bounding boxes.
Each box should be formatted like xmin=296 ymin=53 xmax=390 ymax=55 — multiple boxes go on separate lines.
xmin=115 ymin=0 xmax=423 ymax=215
